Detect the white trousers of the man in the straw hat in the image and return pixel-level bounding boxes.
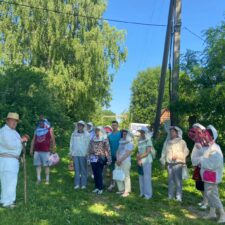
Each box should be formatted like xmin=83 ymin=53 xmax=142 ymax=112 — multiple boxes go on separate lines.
xmin=0 ymin=157 xmax=19 ymax=206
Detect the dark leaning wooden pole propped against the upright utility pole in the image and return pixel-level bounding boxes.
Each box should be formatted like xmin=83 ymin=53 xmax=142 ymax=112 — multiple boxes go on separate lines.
xmin=153 ymin=0 xmax=174 ymax=138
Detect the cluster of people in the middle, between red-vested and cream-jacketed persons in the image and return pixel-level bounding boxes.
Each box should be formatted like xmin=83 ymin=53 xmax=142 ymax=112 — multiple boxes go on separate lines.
xmin=69 ymin=121 xmax=155 ymax=199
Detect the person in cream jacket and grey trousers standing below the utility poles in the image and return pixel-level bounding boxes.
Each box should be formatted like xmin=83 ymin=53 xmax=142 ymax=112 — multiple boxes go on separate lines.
xmin=160 ymin=127 xmax=189 ymax=201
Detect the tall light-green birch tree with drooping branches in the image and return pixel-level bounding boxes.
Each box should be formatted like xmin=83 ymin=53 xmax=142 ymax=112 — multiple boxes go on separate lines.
xmin=0 ymin=0 xmax=126 ymax=123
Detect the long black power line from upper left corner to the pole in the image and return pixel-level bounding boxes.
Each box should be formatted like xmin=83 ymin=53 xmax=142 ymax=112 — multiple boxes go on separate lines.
xmin=0 ymin=1 xmax=166 ymax=27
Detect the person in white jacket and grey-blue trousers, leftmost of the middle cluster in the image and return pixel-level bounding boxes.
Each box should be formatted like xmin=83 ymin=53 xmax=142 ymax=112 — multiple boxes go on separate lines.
xmin=69 ymin=120 xmax=90 ymax=189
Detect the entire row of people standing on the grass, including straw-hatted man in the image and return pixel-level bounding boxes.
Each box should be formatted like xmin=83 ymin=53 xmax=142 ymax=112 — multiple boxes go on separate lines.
xmin=0 ymin=113 xmax=225 ymax=223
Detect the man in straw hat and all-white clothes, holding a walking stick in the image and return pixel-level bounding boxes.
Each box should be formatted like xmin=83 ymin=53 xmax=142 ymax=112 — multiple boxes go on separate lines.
xmin=0 ymin=112 xmax=28 ymax=208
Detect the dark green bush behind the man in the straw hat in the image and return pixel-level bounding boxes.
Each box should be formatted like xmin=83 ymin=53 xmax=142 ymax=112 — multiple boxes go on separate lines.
xmin=0 ymin=66 xmax=71 ymax=145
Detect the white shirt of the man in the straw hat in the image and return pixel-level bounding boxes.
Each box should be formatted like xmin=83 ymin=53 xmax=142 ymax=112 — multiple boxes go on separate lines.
xmin=0 ymin=125 xmax=23 ymax=156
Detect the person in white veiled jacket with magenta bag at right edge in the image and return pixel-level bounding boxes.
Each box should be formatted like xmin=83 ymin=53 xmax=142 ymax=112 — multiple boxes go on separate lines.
xmin=200 ymin=125 xmax=225 ymax=223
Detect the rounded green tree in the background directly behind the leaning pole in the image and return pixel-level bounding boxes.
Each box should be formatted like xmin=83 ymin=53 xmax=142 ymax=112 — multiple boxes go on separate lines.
xmin=130 ymin=67 xmax=169 ymax=124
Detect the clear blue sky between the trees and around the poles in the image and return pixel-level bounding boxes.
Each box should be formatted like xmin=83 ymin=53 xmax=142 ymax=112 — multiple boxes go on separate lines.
xmin=104 ymin=0 xmax=225 ymax=114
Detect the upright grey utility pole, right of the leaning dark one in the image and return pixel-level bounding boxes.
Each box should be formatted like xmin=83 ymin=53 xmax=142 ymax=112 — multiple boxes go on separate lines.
xmin=170 ymin=0 xmax=181 ymax=125
